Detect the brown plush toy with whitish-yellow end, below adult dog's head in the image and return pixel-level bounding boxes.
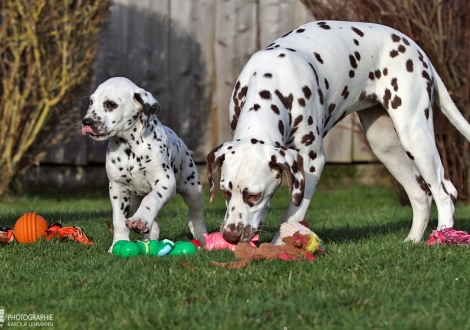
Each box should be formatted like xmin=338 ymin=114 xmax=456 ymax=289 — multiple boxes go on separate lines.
xmin=211 ymin=222 xmax=325 ymax=269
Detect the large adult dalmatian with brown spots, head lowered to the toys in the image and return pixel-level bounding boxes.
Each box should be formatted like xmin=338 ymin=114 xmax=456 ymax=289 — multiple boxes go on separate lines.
xmin=207 ymin=21 xmax=470 ymax=243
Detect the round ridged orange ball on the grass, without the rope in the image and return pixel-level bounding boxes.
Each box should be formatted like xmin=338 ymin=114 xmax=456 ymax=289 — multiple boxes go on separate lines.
xmin=13 ymin=212 xmax=49 ymax=244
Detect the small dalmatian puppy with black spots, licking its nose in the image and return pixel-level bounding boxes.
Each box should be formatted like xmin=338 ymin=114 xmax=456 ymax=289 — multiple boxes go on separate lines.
xmin=82 ymin=77 xmax=207 ymax=251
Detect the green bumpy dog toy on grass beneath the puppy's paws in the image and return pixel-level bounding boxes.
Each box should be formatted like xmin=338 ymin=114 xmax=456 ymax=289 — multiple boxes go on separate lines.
xmin=112 ymin=239 xmax=199 ymax=258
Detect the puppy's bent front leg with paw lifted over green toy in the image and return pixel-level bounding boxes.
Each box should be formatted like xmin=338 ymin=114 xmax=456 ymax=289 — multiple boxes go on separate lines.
xmin=126 ymin=179 xmax=176 ymax=239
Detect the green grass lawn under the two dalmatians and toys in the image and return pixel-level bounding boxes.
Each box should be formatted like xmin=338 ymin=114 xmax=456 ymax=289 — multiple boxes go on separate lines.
xmin=0 ymin=186 xmax=470 ymax=330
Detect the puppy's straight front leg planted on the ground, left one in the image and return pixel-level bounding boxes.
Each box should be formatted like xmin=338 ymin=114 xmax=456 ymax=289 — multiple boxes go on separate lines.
xmin=108 ymin=182 xmax=131 ymax=252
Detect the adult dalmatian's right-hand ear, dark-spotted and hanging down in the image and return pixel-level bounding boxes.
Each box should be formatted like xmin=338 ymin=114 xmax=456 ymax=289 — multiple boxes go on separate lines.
xmin=269 ymin=147 xmax=305 ymax=206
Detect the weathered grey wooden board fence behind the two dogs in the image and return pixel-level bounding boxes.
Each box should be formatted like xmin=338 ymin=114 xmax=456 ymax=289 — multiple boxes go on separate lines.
xmin=28 ymin=0 xmax=374 ymax=184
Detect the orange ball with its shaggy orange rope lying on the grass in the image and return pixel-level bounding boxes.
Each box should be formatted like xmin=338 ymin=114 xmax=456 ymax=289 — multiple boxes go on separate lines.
xmin=0 ymin=212 xmax=93 ymax=245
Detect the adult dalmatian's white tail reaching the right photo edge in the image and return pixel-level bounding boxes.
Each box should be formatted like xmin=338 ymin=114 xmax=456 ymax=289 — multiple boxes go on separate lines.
xmin=432 ymin=67 xmax=470 ymax=141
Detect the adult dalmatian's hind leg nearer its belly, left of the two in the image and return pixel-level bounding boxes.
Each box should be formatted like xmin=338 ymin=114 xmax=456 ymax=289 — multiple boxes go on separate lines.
xmin=357 ymin=104 xmax=432 ymax=242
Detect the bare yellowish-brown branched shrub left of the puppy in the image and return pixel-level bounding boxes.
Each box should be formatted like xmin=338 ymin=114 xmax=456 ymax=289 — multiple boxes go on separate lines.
xmin=0 ymin=0 xmax=110 ymax=196
